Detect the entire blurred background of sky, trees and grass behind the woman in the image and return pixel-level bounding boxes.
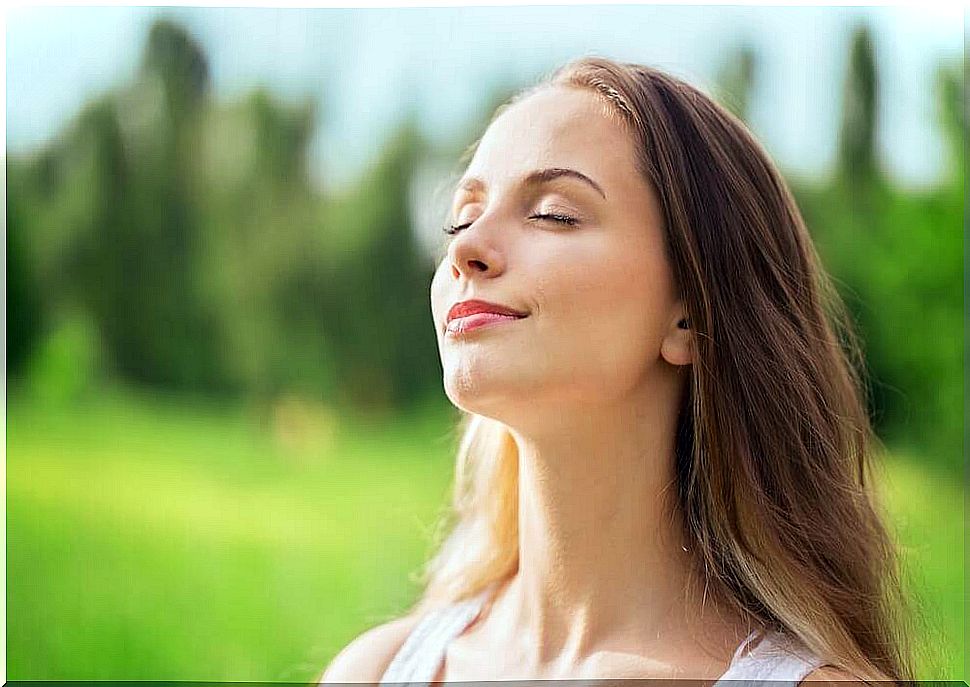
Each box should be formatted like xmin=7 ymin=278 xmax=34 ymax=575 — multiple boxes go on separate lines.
xmin=6 ymin=5 xmax=968 ymax=681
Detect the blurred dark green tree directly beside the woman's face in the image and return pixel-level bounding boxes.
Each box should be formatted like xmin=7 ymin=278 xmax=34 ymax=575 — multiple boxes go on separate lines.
xmin=327 ymin=118 xmax=441 ymax=406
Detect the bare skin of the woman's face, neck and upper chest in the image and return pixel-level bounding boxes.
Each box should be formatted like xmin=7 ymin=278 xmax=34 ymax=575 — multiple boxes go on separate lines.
xmin=431 ymin=87 xmax=751 ymax=681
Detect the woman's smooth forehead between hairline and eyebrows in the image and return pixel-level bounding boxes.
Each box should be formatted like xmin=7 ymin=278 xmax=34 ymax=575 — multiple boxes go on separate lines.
xmin=464 ymin=87 xmax=635 ymax=194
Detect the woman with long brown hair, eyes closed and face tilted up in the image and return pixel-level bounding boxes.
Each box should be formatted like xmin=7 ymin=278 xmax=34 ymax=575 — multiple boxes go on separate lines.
xmin=323 ymin=57 xmax=912 ymax=683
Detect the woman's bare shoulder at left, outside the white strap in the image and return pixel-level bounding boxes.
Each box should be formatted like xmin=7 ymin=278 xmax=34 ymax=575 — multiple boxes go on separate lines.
xmin=318 ymin=615 xmax=420 ymax=684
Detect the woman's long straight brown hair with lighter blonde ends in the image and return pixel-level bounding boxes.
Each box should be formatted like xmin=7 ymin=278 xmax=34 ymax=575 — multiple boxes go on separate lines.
xmin=413 ymin=57 xmax=914 ymax=680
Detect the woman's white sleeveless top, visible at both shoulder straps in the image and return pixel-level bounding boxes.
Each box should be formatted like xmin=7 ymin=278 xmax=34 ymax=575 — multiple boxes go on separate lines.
xmin=380 ymin=585 xmax=824 ymax=687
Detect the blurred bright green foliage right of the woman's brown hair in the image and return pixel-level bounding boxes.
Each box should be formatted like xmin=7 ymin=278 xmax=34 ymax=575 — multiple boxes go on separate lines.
xmin=795 ymin=27 xmax=966 ymax=474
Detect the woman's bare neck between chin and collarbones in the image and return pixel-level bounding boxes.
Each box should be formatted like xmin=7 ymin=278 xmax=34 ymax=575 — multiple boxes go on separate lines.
xmin=496 ymin=378 xmax=708 ymax=665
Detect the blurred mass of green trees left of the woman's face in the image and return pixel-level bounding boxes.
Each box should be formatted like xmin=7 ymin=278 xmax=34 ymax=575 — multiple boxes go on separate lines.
xmin=9 ymin=20 xmax=440 ymax=414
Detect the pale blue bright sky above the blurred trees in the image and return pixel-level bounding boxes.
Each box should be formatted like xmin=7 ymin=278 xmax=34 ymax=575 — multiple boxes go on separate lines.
xmin=6 ymin=5 xmax=964 ymax=191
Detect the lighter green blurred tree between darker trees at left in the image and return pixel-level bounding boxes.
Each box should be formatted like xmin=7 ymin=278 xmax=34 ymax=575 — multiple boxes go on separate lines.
xmin=196 ymin=89 xmax=339 ymax=398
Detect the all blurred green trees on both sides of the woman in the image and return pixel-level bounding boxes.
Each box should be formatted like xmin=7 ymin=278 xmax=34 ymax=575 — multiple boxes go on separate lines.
xmin=8 ymin=20 xmax=965 ymax=468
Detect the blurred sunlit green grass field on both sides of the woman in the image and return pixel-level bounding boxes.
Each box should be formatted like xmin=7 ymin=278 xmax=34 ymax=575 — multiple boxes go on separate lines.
xmin=7 ymin=395 xmax=967 ymax=682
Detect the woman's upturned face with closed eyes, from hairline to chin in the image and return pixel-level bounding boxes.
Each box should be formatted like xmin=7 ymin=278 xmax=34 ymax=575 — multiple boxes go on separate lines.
xmin=431 ymin=87 xmax=689 ymax=420
